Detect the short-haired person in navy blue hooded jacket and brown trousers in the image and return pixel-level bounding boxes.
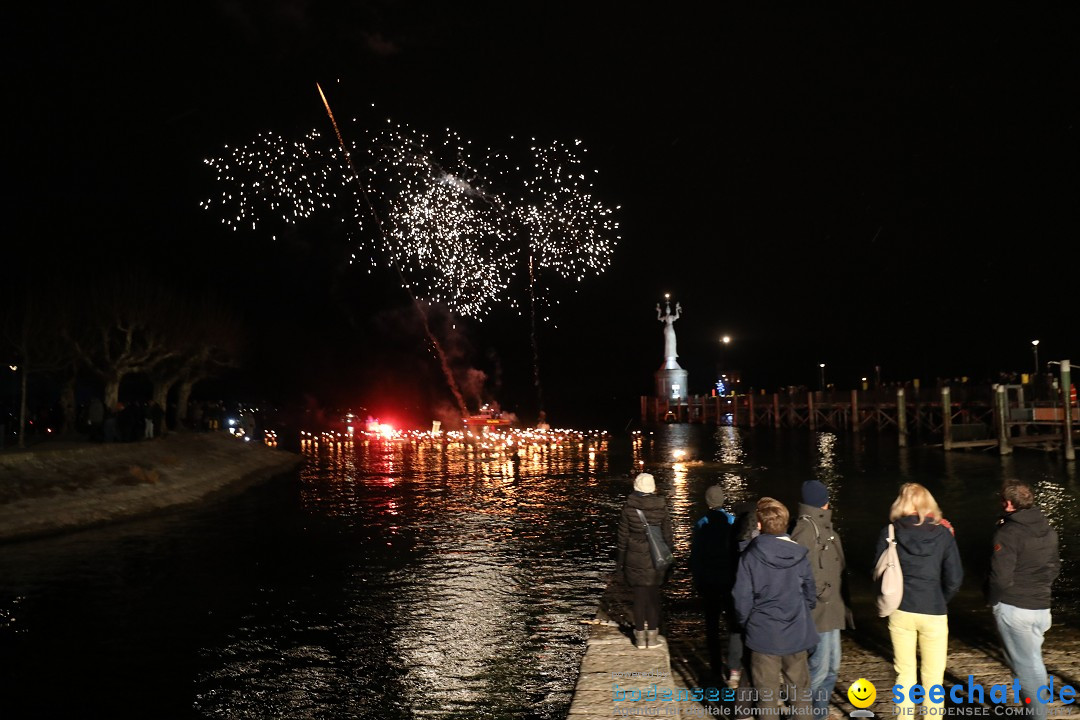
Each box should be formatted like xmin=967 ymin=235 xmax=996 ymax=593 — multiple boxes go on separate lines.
xmin=732 ymin=498 xmax=818 ymax=717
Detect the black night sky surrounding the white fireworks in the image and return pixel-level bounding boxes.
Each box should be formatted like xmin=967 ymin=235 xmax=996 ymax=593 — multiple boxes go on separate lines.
xmin=0 ymin=0 xmax=1080 ymax=429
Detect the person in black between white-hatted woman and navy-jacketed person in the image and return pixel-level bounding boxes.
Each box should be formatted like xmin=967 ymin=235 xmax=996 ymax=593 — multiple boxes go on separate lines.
xmin=690 ymin=485 xmax=743 ymax=685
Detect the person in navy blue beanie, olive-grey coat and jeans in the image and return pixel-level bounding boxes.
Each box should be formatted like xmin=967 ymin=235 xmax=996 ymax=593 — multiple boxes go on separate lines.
xmin=792 ymin=480 xmax=848 ymax=718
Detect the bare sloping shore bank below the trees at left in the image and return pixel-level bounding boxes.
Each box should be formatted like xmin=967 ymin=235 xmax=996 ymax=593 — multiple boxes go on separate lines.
xmin=0 ymin=433 xmax=303 ymax=543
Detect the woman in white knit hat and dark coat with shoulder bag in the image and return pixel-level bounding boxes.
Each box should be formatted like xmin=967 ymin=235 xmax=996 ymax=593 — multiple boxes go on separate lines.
xmin=616 ymin=473 xmax=674 ymax=650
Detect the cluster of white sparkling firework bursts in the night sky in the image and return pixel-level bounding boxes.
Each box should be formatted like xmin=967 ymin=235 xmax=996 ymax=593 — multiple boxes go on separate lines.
xmin=202 ymin=97 xmax=619 ymax=335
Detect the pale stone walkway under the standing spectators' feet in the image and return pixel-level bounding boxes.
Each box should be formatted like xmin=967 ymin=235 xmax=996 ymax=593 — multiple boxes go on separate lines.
xmin=568 ymin=581 xmax=1080 ymax=720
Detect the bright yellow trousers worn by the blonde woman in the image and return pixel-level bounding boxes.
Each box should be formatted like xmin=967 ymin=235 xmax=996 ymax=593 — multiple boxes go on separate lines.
xmin=889 ymin=610 xmax=948 ymax=712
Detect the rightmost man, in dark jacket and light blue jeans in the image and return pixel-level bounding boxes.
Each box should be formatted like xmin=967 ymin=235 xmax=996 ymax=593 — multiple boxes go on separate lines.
xmin=988 ymin=480 xmax=1061 ymax=718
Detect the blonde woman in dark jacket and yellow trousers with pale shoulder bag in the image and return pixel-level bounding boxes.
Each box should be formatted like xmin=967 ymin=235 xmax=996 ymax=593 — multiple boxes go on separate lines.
xmin=875 ymin=483 xmax=963 ymax=714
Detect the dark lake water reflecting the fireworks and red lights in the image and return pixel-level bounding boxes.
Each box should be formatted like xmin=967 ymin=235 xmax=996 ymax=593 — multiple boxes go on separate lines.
xmin=0 ymin=425 xmax=1080 ymax=719
